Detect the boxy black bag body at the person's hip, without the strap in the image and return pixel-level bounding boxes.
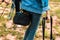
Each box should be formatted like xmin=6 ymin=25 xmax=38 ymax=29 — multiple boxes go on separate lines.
xmin=13 ymin=12 xmax=31 ymax=26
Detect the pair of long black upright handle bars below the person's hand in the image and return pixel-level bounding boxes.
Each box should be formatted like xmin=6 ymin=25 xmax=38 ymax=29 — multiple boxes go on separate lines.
xmin=42 ymin=16 xmax=53 ymax=40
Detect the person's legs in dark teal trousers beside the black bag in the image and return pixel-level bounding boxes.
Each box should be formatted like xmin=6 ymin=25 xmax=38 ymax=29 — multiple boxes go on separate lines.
xmin=24 ymin=13 xmax=41 ymax=40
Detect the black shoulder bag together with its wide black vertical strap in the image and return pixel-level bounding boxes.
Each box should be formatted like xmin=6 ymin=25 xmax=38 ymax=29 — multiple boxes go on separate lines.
xmin=13 ymin=0 xmax=31 ymax=26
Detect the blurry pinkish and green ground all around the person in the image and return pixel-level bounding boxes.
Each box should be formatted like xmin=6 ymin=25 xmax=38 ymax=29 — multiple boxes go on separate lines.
xmin=0 ymin=2 xmax=60 ymax=40
